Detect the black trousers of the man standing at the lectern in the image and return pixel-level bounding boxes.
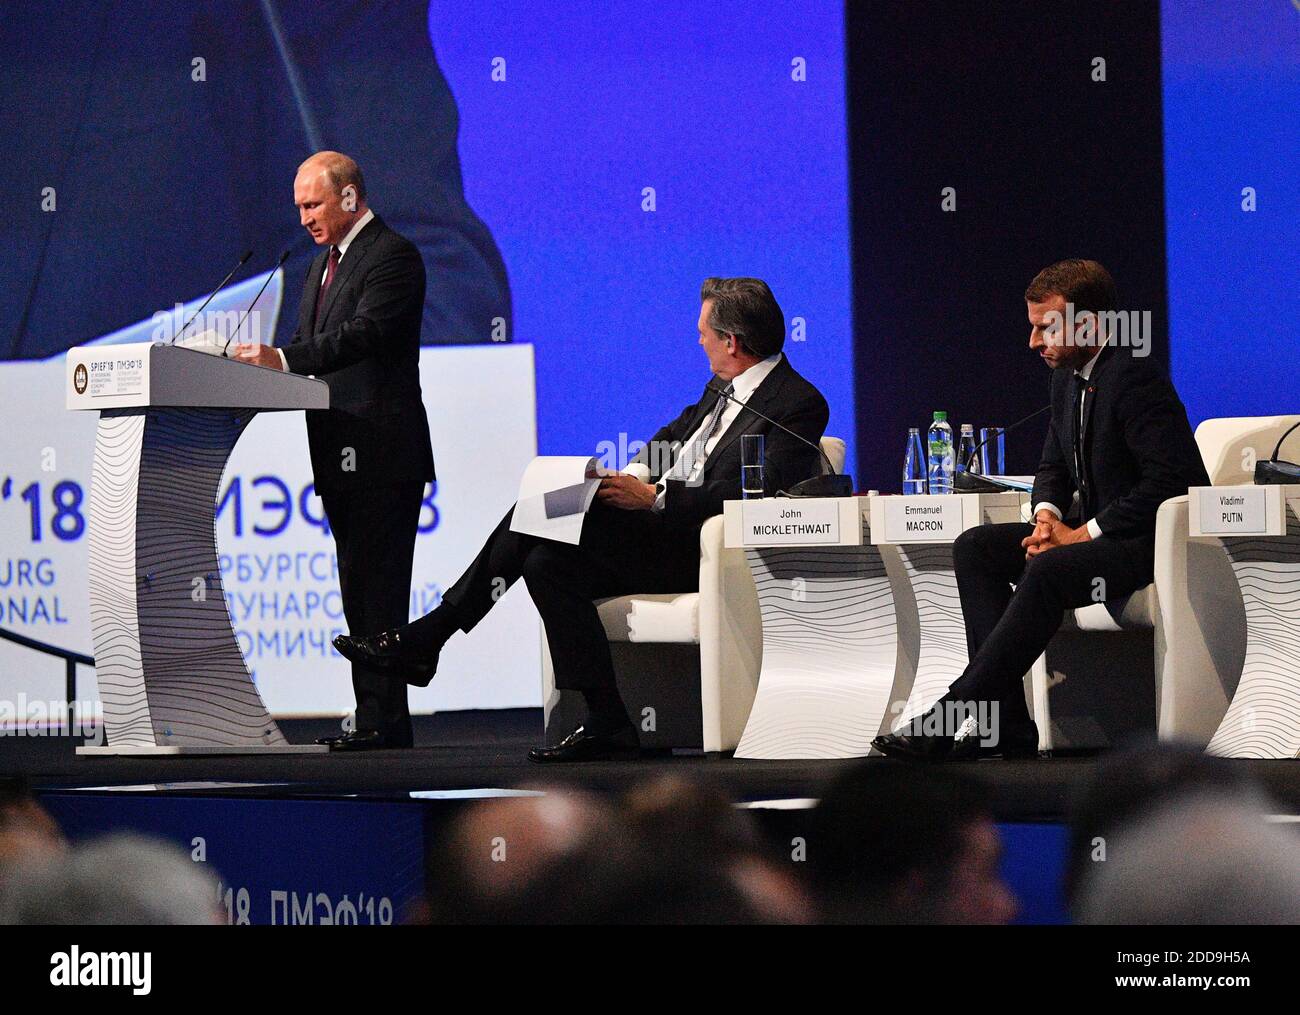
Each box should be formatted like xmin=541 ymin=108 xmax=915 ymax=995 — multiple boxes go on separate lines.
xmin=320 ymin=480 xmax=424 ymax=747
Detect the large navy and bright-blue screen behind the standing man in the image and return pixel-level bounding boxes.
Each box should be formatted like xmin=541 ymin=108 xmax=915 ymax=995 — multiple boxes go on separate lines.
xmin=0 ymin=0 xmax=853 ymax=468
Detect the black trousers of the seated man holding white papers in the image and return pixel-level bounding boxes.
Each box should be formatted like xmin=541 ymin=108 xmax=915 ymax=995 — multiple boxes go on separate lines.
xmin=418 ymin=502 xmax=699 ymax=690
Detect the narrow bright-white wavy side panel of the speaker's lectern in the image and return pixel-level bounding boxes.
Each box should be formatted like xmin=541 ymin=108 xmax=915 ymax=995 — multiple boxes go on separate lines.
xmin=86 ymin=411 xmax=153 ymax=747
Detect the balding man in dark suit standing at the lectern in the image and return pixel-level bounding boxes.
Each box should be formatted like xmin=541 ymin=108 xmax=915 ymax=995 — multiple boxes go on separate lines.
xmin=237 ymin=152 xmax=434 ymax=750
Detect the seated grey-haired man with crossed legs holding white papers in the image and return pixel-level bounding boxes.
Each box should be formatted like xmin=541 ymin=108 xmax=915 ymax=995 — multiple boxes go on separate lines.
xmin=334 ymin=278 xmax=829 ymax=762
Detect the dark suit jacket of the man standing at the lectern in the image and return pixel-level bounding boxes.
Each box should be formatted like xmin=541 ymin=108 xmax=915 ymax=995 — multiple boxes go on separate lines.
xmin=285 ymin=216 xmax=434 ymax=491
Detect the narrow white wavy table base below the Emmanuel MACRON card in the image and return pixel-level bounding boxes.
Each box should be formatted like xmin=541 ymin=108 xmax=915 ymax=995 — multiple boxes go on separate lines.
xmin=896 ymin=543 xmax=969 ymax=728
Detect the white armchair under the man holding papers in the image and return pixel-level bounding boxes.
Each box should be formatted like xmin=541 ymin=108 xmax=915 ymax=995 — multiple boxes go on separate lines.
xmin=542 ymin=437 xmax=845 ymax=751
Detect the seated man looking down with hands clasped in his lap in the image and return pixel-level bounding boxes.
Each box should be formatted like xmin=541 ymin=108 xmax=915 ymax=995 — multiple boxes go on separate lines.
xmin=874 ymin=260 xmax=1209 ymax=760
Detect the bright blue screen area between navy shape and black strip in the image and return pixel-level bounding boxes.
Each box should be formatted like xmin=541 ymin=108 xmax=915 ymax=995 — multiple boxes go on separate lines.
xmin=429 ymin=0 xmax=853 ymax=470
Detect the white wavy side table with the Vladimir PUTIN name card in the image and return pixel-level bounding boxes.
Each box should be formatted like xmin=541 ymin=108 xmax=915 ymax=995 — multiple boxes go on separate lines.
xmin=1187 ymin=486 xmax=1300 ymax=758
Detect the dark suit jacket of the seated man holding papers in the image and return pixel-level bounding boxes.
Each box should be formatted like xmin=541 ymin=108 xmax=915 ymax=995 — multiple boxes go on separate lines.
xmin=633 ymin=356 xmax=831 ymax=529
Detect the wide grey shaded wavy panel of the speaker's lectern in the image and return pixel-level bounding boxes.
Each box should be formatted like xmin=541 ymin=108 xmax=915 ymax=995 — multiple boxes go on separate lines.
xmin=134 ymin=408 xmax=286 ymax=746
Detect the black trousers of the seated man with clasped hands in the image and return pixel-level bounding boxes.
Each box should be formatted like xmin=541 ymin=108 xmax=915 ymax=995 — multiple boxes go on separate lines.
xmin=944 ymin=522 xmax=1156 ymax=721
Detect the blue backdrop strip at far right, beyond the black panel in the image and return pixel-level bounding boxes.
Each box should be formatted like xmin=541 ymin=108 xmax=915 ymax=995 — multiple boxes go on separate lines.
xmin=1161 ymin=0 xmax=1300 ymax=425
